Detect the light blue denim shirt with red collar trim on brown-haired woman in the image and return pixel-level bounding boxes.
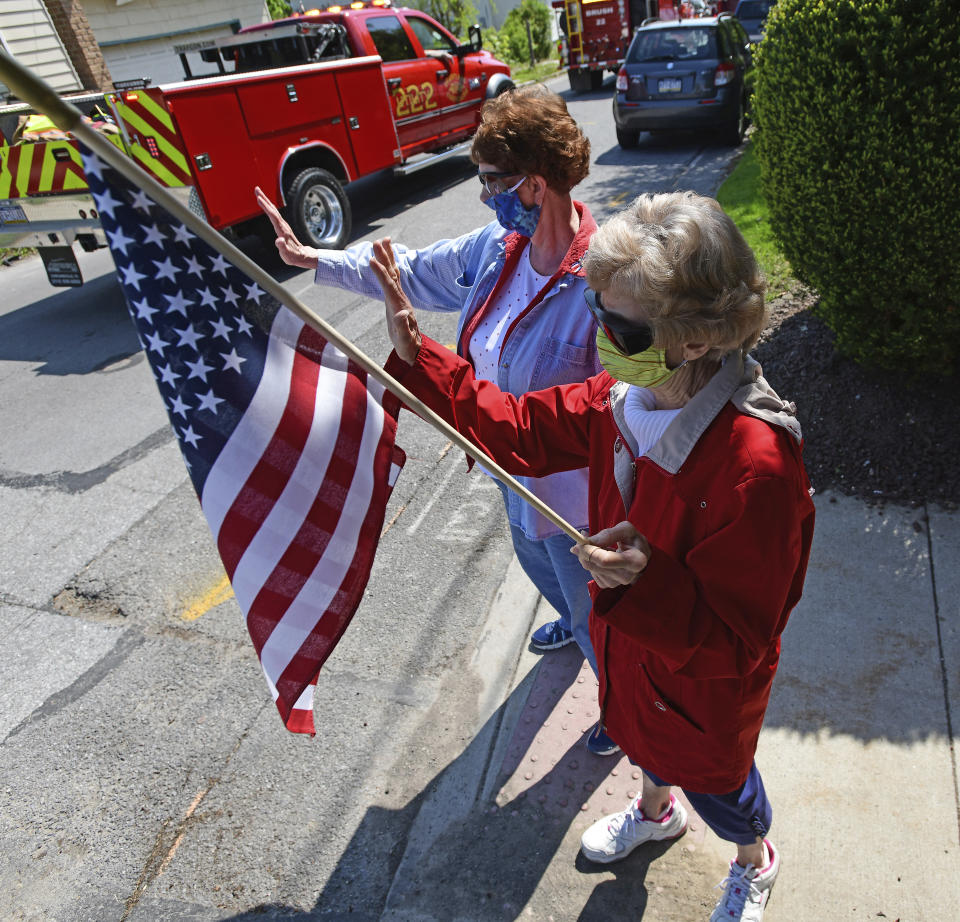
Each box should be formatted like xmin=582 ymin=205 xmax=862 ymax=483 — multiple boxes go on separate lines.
xmin=315 ymin=202 xmax=602 ymax=539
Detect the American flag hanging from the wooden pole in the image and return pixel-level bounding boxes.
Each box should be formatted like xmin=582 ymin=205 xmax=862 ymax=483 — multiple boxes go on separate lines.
xmin=84 ymin=146 xmax=404 ymax=734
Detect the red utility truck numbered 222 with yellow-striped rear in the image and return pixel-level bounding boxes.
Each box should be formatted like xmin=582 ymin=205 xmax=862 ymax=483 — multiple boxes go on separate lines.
xmin=0 ymin=0 xmax=513 ymax=285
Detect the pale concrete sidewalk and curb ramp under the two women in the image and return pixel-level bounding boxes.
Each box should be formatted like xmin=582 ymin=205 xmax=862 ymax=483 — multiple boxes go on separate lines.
xmin=384 ymin=494 xmax=960 ymax=922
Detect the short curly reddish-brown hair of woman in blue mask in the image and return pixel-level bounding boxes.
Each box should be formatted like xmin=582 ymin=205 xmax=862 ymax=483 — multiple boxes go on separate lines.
xmin=470 ymin=83 xmax=590 ymax=193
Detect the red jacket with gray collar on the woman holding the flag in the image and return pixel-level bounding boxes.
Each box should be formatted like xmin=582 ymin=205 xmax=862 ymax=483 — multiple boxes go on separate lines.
xmin=387 ymin=337 xmax=814 ymax=794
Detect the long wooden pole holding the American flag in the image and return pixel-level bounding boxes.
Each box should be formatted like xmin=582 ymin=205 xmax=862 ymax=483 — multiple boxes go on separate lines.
xmin=0 ymin=50 xmax=587 ymax=544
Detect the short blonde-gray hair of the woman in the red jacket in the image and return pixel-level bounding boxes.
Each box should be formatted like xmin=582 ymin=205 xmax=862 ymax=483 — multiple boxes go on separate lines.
xmin=583 ymin=192 xmax=768 ymax=357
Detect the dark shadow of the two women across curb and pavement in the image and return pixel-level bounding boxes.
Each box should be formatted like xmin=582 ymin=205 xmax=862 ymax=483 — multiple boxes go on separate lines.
xmin=212 ymin=656 xmax=652 ymax=922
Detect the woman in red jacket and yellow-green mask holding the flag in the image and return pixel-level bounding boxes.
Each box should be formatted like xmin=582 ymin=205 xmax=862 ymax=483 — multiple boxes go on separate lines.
xmin=374 ymin=192 xmax=814 ymax=922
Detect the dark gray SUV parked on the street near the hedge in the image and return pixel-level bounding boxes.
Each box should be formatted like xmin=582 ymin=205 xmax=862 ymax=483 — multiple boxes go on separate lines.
xmin=613 ymin=13 xmax=753 ymax=148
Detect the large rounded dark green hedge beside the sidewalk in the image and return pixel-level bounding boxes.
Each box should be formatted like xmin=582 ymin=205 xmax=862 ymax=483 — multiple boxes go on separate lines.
xmin=753 ymin=0 xmax=960 ymax=374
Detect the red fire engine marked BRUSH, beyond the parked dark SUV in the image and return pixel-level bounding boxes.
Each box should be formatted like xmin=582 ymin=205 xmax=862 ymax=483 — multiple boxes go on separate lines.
xmin=551 ymin=0 xmax=712 ymax=93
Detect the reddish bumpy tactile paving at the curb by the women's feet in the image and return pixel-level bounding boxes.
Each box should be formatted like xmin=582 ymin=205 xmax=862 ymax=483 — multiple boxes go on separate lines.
xmin=488 ymin=644 xmax=705 ymax=850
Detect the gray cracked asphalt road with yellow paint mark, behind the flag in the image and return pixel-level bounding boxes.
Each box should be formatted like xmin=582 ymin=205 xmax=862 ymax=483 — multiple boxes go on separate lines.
xmin=0 ymin=75 xmax=744 ymax=922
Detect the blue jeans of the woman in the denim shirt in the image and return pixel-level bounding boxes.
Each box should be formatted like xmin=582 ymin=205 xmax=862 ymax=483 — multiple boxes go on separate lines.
xmin=510 ymin=525 xmax=597 ymax=675
